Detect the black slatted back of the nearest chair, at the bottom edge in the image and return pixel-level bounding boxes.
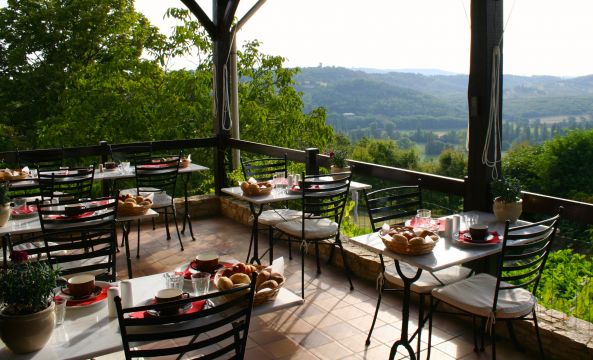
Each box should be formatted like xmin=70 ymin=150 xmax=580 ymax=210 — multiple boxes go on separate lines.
xmin=115 ymin=273 xmax=256 ymax=359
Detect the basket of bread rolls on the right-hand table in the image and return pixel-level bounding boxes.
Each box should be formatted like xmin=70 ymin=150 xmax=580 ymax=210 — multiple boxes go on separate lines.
xmin=379 ymin=224 xmax=439 ymax=255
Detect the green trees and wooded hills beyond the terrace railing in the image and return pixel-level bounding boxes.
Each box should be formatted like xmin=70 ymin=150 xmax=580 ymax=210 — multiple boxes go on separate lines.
xmin=0 ymin=0 xmax=593 ymax=320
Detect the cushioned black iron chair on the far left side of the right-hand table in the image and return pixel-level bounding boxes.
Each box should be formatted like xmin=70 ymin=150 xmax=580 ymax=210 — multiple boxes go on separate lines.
xmin=363 ymin=185 xmax=471 ymax=354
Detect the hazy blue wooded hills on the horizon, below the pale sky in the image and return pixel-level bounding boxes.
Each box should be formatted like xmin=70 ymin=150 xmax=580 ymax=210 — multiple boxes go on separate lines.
xmin=295 ymin=67 xmax=593 ymax=131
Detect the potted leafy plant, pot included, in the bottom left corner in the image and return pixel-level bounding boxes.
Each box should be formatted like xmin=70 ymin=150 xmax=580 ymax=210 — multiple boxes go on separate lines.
xmin=0 ymin=251 xmax=58 ymax=354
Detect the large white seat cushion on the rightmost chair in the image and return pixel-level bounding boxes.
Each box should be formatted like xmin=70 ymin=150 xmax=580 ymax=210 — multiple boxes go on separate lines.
xmin=432 ymin=274 xmax=535 ymax=318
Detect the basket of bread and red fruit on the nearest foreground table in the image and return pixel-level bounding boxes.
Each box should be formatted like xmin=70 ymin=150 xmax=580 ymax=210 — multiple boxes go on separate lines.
xmin=214 ymin=265 xmax=285 ymax=305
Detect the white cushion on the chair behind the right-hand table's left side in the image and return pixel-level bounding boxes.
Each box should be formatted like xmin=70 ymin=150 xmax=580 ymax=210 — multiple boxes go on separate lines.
xmin=385 ymin=262 xmax=471 ymax=294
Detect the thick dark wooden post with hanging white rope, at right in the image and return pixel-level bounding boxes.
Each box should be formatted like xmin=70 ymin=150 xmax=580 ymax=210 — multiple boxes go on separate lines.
xmin=464 ymin=0 xmax=503 ymax=211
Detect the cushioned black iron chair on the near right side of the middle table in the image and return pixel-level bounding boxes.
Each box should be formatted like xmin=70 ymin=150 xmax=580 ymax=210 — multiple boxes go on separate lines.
xmin=276 ymin=173 xmax=354 ymax=299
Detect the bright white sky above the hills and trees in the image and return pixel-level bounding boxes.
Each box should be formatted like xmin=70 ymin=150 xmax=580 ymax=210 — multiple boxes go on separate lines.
xmin=136 ymin=0 xmax=593 ymax=76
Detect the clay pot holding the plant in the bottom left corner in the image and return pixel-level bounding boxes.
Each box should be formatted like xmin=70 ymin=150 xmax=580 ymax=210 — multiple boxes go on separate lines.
xmin=0 ymin=301 xmax=56 ymax=354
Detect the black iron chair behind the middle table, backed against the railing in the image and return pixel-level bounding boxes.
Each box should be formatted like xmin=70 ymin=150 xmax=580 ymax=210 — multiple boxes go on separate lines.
xmin=241 ymin=155 xmax=301 ymax=264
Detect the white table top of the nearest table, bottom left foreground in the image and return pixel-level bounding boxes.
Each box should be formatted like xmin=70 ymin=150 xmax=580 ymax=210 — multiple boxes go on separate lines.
xmin=0 ymin=274 xmax=303 ymax=360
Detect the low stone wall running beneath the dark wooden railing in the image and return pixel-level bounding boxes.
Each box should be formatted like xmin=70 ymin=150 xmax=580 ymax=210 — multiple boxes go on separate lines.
xmin=192 ymin=196 xmax=593 ymax=360
